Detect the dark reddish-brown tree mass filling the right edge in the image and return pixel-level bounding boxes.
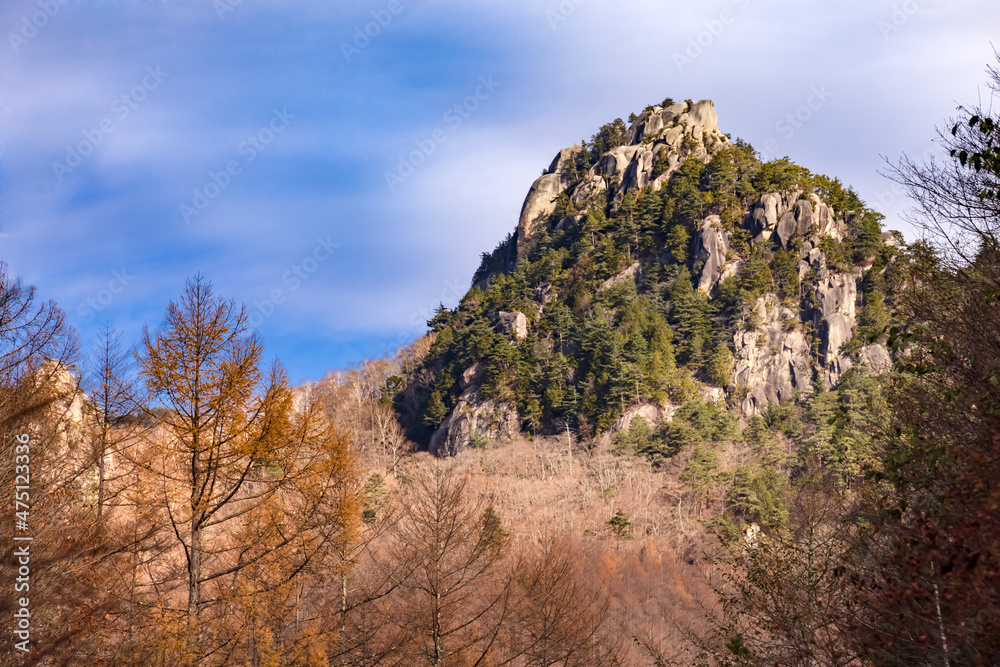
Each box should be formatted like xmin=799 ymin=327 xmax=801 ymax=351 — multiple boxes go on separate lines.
xmin=717 ymin=54 xmax=1000 ymax=665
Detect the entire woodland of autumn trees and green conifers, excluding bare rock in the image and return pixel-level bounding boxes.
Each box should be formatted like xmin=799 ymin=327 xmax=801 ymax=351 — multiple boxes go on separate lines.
xmin=0 ymin=56 xmax=1000 ymax=667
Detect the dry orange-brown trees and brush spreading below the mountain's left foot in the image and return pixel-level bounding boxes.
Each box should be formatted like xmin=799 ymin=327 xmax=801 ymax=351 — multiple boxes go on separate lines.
xmin=0 ymin=272 xmax=732 ymax=667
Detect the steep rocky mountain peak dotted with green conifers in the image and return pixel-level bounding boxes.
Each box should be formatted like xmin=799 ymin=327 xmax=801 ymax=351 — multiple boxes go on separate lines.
xmin=404 ymin=99 xmax=903 ymax=455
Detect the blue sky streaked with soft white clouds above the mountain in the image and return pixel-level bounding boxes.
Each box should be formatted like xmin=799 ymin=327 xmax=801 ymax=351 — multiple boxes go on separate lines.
xmin=0 ymin=0 xmax=1000 ymax=380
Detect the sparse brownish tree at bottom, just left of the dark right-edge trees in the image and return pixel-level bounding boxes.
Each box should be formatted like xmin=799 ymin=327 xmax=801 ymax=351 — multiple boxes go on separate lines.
xmin=701 ymin=470 xmax=858 ymax=667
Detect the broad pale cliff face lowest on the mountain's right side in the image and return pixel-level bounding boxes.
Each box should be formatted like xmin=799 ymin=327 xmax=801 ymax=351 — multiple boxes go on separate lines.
xmin=733 ymin=294 xmax=812 ymax=415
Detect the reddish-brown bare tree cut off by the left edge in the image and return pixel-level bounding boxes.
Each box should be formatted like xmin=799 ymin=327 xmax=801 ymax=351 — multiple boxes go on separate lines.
xmin=0 ymin=263 xmax=141 ymax=665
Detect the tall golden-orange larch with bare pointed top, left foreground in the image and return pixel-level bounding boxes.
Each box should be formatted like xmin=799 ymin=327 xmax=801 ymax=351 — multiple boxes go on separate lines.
xmin=138 ymin=276 xmax=358 ymax=664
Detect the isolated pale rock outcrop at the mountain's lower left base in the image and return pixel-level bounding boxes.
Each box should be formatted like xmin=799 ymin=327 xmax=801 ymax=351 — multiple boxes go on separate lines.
xmin=428 ymin=386 xmax=520 ymax=456
